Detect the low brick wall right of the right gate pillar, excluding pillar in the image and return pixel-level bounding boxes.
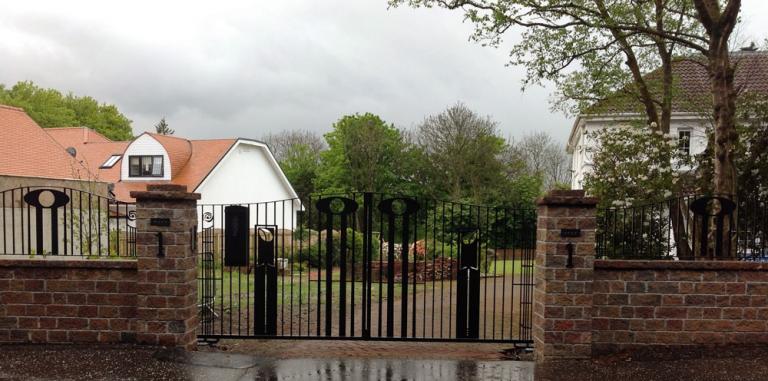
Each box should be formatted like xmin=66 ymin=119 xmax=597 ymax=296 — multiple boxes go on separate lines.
xmin=592 ymin=260 xmax=768 ymax=355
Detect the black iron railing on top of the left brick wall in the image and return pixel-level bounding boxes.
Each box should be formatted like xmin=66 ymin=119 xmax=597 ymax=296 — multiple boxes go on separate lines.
xmin=0 ymin=187 xmax=136 ymax=257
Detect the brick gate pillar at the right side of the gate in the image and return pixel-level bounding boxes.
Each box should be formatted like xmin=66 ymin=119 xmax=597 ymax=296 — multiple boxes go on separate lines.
xmin=533 ymin=190 xmax=597 ymax=361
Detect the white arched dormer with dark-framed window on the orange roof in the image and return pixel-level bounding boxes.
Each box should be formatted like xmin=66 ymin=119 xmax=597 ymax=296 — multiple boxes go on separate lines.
xmin=120 ymin=134 xmax=172 ymax=181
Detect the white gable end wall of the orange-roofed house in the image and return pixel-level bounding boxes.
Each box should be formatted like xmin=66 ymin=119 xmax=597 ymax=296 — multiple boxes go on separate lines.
xmin=196 ymin=141 xmax=301 ymax=230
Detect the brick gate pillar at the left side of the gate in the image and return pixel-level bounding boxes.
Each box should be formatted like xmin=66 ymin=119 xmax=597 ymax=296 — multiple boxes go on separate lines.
xmin=131 ymin=184 xmax=200 ymax=349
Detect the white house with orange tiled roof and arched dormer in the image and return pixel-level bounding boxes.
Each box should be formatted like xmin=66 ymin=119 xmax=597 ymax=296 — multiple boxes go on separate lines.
xmin=45 ymin=127 xmax=301 ymax=229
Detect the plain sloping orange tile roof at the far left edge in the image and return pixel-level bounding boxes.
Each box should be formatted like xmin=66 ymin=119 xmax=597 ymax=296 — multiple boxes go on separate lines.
xmin=0 ymin=105 xmax=90 ymax=180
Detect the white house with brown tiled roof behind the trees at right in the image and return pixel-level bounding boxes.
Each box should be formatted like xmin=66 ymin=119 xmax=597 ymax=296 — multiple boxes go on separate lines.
xmin=566 ymin=51 xmax=768 ymax=189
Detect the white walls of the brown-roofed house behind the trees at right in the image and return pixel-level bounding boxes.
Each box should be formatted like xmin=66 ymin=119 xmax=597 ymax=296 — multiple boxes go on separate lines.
xmin=571 ymin=115 xmax=710 ymax=189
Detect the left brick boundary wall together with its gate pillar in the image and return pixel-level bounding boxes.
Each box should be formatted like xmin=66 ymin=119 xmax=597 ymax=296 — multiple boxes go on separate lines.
xmin=0 ymin=184 xmax=200 ymax=349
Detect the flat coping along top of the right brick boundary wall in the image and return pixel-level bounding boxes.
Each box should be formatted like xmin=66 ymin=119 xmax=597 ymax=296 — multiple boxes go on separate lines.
xmin=595 ymin=259 xmax=768 ymax=271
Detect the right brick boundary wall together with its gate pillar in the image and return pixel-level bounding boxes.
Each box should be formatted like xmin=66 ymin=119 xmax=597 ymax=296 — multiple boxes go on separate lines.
xmin=533 ymin=191 xmax=768 ymax=361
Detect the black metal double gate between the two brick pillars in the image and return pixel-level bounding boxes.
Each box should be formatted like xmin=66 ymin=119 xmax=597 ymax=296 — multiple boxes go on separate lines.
xmin=198 ymin=193 xmax=536 ymax=344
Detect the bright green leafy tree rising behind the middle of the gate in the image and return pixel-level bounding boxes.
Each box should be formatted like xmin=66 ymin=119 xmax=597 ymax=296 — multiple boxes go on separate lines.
xmin=315 ymin=113 xmax=418 ymax=193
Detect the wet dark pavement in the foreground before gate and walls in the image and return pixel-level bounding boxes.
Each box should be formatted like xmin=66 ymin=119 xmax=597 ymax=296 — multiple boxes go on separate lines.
xmin=0 ymin=345 xmax=768 ymax=381
